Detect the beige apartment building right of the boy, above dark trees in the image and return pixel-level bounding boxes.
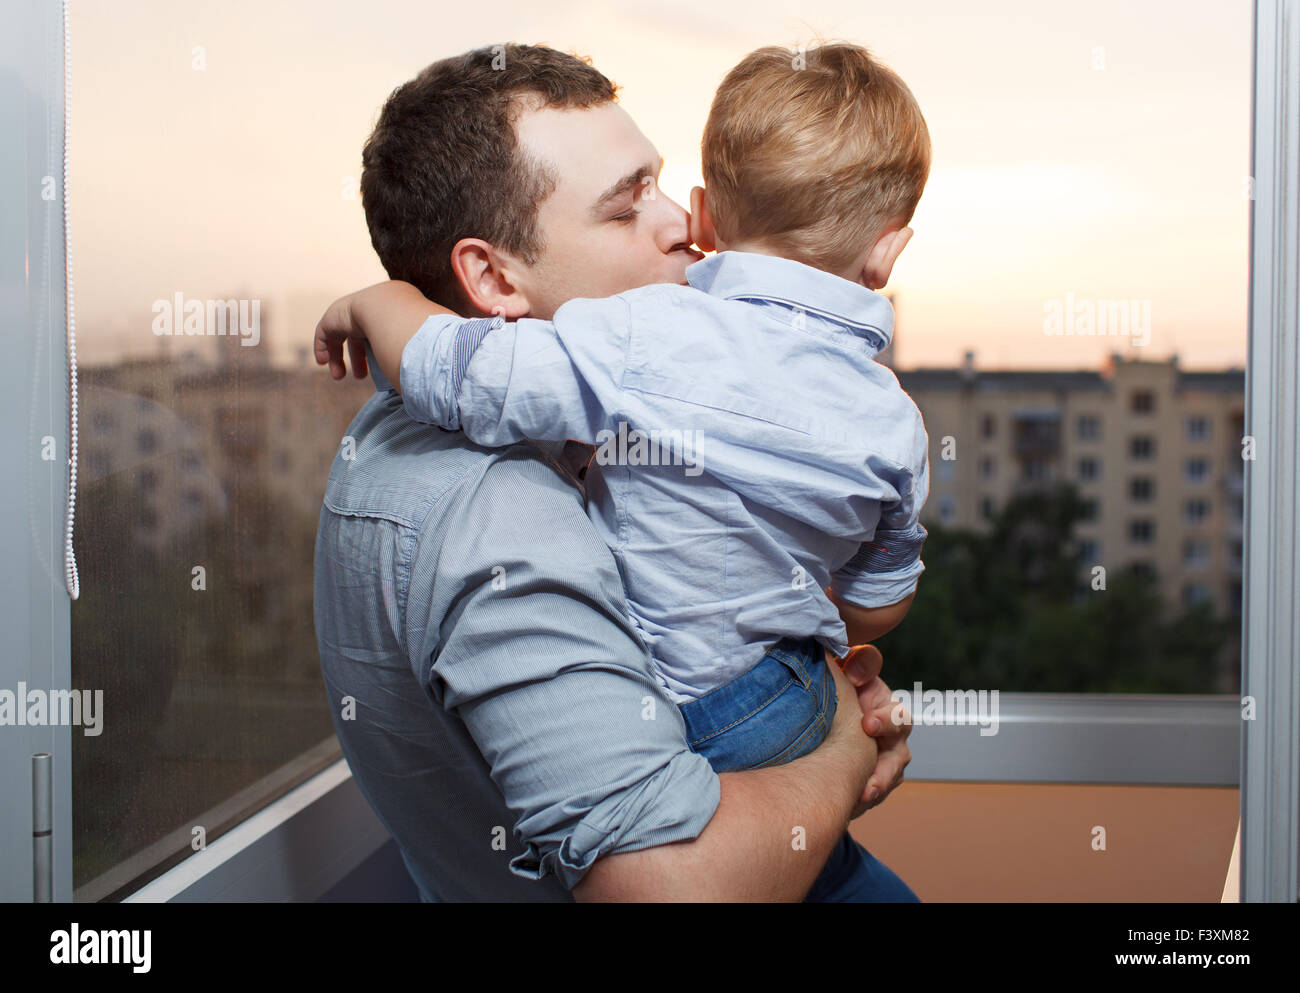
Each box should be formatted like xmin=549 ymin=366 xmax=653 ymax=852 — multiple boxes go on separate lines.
xmin=896 ymin=352 xmax=1245 ymax=617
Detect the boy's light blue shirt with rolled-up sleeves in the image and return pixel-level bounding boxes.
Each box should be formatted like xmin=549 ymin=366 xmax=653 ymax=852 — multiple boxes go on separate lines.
xmin=402 ymin=252 xmax=930 ymax=703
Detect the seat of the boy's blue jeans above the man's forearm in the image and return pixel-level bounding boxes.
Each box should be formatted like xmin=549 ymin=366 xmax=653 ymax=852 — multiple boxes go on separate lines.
xmin=680 ymin=641 xmax=836 ymax=772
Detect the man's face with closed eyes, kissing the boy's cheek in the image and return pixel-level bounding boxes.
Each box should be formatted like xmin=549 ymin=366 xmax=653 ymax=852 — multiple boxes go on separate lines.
xmin=504 ymin=103 xmax=703 ymax=320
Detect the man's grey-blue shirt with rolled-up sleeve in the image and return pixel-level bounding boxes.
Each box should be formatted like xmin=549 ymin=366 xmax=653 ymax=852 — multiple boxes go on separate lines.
xmin=315 ymin=376 xmax=722 ymax=902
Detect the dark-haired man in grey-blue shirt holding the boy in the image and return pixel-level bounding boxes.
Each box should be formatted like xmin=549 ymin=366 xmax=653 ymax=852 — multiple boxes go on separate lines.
xmin=315 ymin=45 xmax=914 ymax=899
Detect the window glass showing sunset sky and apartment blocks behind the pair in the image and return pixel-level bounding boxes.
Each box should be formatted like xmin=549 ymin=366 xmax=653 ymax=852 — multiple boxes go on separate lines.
xmin=63 ymin=0 xmax=1251 ymax=898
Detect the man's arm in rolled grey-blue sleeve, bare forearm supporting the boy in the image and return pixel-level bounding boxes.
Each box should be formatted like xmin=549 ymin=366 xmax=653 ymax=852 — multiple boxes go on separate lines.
xmin=407 ymin=452 xmax=876 ymax=899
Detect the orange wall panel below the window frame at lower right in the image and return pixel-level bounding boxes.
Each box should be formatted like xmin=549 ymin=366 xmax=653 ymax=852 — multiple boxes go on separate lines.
xmin=853 ymin=782 xmax=1239 ymax=902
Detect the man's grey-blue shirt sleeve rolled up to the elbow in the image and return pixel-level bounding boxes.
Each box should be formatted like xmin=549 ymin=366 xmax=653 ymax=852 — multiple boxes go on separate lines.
xmin=404 ymin=452 xmax=720 ymax=888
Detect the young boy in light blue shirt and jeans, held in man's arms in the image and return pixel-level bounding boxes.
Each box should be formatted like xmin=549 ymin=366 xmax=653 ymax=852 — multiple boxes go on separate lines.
xmin=316 ymin=44 xmax=930 ymax=772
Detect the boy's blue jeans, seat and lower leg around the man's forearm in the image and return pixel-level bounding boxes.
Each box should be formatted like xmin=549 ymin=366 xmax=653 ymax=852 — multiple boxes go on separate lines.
xmin=680 ymin=638 xmax=919 ymax=903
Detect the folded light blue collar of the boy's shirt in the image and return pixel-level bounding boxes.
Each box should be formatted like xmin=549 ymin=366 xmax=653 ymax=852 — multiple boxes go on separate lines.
xmin=686 ymin=252 xmax=893 ymax=350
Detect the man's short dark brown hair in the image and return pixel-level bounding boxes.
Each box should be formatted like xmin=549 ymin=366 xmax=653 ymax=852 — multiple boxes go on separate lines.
xmin=361 ymin=44 xmax=618 ymax=307
